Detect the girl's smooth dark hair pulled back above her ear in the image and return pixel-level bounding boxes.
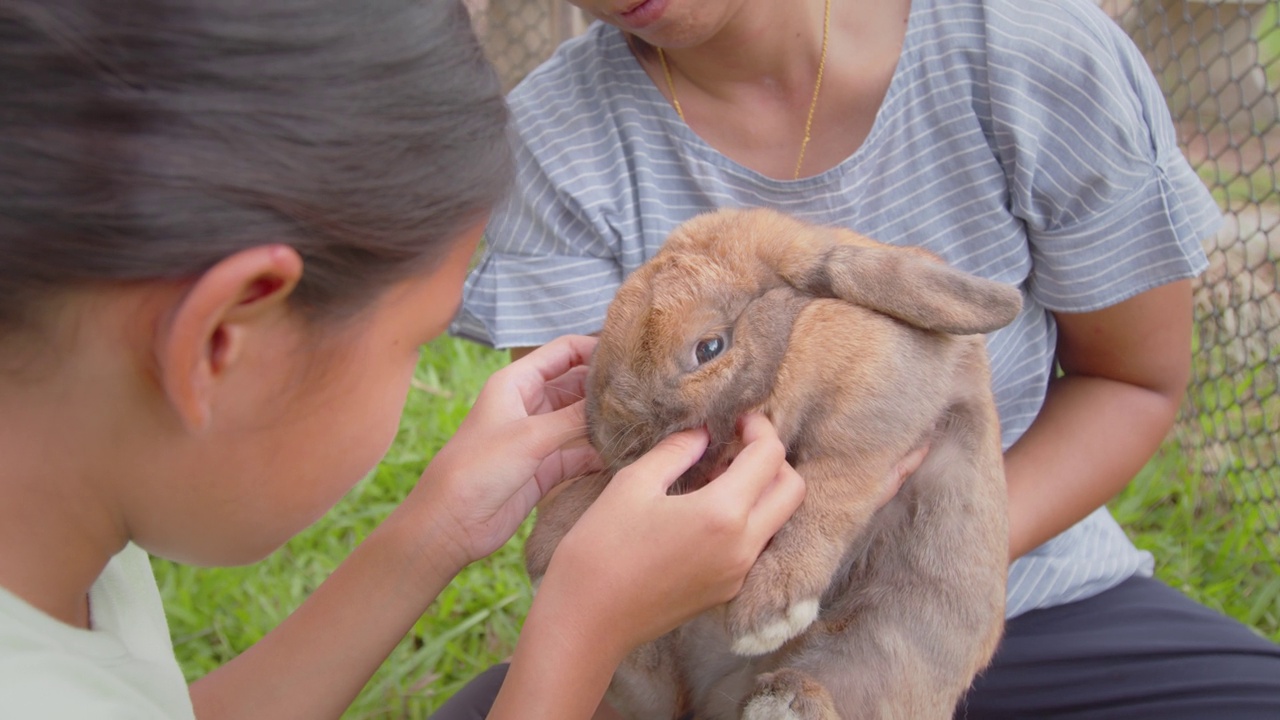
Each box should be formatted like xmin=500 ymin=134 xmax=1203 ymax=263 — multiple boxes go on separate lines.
xmin=0 ymin=0 xmax=511 ymax=340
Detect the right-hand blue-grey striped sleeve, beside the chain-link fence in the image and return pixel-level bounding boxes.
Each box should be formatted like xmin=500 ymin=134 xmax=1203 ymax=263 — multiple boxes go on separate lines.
xmin=988 ymin=0 xmax=1221 ymax=313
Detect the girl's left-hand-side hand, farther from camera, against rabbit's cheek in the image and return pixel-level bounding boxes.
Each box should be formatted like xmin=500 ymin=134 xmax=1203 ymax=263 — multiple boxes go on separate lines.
xmin=404 ymin=336 xmax=600 ymax=566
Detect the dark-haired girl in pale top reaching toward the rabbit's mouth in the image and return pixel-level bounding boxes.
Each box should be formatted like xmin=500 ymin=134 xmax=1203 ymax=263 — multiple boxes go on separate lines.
xmin=0 ymin=0 xmax=804 ymax=719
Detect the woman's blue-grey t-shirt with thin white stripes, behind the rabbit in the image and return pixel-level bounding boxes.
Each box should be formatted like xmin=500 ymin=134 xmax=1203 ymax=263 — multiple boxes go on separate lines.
xmin=452 ymin=0 xmax=1220 ymax=616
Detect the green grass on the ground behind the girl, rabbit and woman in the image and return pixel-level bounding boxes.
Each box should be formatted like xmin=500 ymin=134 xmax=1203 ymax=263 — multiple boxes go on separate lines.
xmin=155 ymin=340 xmax=1280 ymax=719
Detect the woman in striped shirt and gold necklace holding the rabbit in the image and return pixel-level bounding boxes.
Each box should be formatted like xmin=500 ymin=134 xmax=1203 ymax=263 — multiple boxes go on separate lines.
xmin=452 ymin=0 xmax=1280 ymax=719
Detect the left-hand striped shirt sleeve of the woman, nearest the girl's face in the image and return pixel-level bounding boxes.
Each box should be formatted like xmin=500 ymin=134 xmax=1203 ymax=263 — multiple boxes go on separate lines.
xmin=451 ymin=38 xmax=626 ymax=347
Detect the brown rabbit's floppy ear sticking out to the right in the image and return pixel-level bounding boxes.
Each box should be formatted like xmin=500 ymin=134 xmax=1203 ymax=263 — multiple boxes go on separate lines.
xmin=781 ymin=228 xmax=1023 ymax=334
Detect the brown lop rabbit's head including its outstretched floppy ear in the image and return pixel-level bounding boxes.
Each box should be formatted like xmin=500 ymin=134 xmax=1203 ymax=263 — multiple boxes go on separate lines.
xmin=588 ymin=210 xmax=1021 ymax=487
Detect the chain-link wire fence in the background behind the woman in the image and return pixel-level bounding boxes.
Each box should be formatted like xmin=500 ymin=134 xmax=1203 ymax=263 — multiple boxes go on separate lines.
xmin=472 ymin=0 xmax=1280 ymax=559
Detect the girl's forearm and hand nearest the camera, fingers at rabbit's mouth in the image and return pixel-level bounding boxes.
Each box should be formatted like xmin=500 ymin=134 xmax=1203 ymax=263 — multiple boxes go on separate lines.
xmin=489 ymin=415 xmax=804 ymax=720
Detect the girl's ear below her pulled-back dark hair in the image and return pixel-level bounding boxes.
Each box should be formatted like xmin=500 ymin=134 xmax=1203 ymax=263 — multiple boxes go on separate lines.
xmin=155 ymin=245 xmax=302 ymax=432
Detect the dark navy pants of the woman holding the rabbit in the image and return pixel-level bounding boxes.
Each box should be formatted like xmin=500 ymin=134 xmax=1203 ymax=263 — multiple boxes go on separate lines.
xmin=433 ymin=578 xmax=1280 ymax=720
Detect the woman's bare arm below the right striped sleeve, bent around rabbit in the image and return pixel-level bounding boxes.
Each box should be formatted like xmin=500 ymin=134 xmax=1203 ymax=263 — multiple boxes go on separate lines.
xmin=1005 ymin=281 xmax=1192 ymax=559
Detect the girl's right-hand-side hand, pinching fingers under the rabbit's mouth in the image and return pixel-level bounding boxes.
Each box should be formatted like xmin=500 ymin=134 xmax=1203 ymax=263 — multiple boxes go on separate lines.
xmin=534 ymin=415 xmax=804 ymax=657
